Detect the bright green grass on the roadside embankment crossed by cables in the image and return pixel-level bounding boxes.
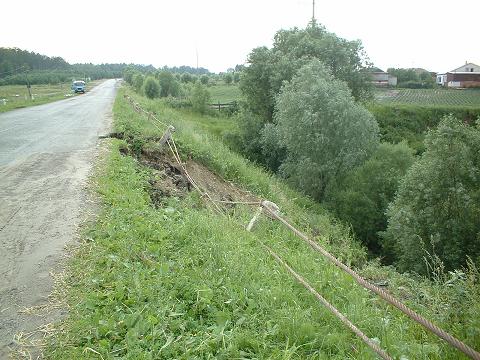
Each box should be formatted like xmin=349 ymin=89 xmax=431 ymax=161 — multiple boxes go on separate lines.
xmin=46 ymin=90 xmax=480 ymax=359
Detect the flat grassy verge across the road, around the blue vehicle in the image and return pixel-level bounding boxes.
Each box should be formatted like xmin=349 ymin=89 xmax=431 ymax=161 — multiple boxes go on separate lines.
xmin=0 ymin=80 xmax=102 ymax=113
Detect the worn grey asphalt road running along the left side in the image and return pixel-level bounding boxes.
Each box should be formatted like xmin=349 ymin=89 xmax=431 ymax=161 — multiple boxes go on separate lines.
xmin=0 ymin=80 xmax=117 ymax=359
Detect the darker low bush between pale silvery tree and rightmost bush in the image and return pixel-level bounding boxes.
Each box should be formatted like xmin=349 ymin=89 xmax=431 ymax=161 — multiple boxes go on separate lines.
xmin=328 ymin=142 xmax=415 ymax=255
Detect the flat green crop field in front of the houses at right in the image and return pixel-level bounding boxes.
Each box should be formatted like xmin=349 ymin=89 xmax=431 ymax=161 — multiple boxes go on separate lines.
xmin=375 ymin=89 xmax=480 ymax=107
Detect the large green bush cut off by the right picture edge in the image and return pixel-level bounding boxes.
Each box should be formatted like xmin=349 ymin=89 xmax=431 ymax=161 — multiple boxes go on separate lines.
xmin=384 ymin=116 xmax=480 ymax=273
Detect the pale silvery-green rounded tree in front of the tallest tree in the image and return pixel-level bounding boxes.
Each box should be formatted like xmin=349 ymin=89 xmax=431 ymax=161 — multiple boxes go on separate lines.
xmin=275 ymin=59 xmax=378 ymax=200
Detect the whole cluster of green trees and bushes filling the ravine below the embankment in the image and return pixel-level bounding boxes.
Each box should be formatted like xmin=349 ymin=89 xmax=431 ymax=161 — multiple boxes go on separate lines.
xmin=230 ymin=22 xmax=480 ymax=273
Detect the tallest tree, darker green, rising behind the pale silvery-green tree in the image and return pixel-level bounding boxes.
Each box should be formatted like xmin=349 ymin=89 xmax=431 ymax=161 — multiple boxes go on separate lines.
xmin=240 ymin=21 xmax=370 ymax=171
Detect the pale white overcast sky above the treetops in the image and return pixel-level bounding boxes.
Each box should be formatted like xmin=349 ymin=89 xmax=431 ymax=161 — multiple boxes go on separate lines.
xmin=0 ymin=0 xmax=480 ymax=72
